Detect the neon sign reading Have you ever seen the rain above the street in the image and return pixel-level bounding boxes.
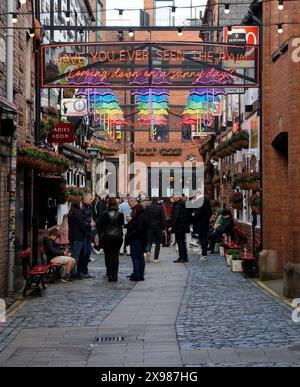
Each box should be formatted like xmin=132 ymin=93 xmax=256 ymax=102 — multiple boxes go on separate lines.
xmin=41 ymin=42 xmax=258 ymax=89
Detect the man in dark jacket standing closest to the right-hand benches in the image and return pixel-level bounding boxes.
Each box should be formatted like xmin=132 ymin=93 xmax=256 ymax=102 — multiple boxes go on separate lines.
xmin=193 ymin=198 xmax=212 ymax=261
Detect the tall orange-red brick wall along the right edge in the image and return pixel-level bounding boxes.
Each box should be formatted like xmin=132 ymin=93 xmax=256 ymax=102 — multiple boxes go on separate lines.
xmin=263 ymin=2 xmax=300 ymax=273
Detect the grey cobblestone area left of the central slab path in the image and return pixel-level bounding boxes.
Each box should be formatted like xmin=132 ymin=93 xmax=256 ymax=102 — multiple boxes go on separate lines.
xmin=0 ymin=255 xmax=134 ymax=352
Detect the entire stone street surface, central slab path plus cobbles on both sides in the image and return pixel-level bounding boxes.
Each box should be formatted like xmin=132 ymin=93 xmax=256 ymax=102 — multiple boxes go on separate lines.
xmin=0 ymin=248 xmax=300 ymax=367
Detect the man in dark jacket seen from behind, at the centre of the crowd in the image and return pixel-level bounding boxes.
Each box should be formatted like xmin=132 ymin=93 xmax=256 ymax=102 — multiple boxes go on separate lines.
xmin=145 ymin=198 xmax=166 ymax=263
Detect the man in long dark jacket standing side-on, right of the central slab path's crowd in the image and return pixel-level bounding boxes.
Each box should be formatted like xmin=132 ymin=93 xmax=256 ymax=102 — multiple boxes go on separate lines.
xmin=172 ymin=197 xmax=190 ymax=262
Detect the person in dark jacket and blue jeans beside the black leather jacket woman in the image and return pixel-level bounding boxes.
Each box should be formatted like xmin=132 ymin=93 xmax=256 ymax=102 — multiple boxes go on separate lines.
xmin=126 ymin=198 xmax=147 ymax=281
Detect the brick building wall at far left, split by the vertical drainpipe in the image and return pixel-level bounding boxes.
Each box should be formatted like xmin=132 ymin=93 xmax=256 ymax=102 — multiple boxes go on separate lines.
xmin=0 ymin=2 xmax=34 ymax=296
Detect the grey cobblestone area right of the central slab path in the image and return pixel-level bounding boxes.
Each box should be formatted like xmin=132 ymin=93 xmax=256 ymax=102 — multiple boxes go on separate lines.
xmin=176 ymin=254 xmax=300 ymax=366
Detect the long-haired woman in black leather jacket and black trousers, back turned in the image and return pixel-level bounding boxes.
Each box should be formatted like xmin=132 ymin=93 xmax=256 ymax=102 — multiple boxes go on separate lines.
xmin=97 ymin=198 xmax=124 ymax=282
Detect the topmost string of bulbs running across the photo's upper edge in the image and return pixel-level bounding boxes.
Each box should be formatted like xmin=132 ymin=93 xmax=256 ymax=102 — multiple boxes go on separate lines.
xmin=0 ymin=0 xmax=300 ymax=17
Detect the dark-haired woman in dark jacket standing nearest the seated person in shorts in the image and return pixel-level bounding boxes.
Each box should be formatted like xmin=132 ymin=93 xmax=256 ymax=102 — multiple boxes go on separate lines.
xmin=68 ymin=200 xmax=88 ymax=279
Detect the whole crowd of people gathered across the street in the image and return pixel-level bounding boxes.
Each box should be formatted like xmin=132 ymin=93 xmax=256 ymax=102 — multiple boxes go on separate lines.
xmin=43 ymin=193 xmax=234 ymax=282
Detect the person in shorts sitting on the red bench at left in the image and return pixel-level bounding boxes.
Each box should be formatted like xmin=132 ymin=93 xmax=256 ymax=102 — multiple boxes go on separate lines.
xmin=43 ymin=229 xmax=76 ymax=282
